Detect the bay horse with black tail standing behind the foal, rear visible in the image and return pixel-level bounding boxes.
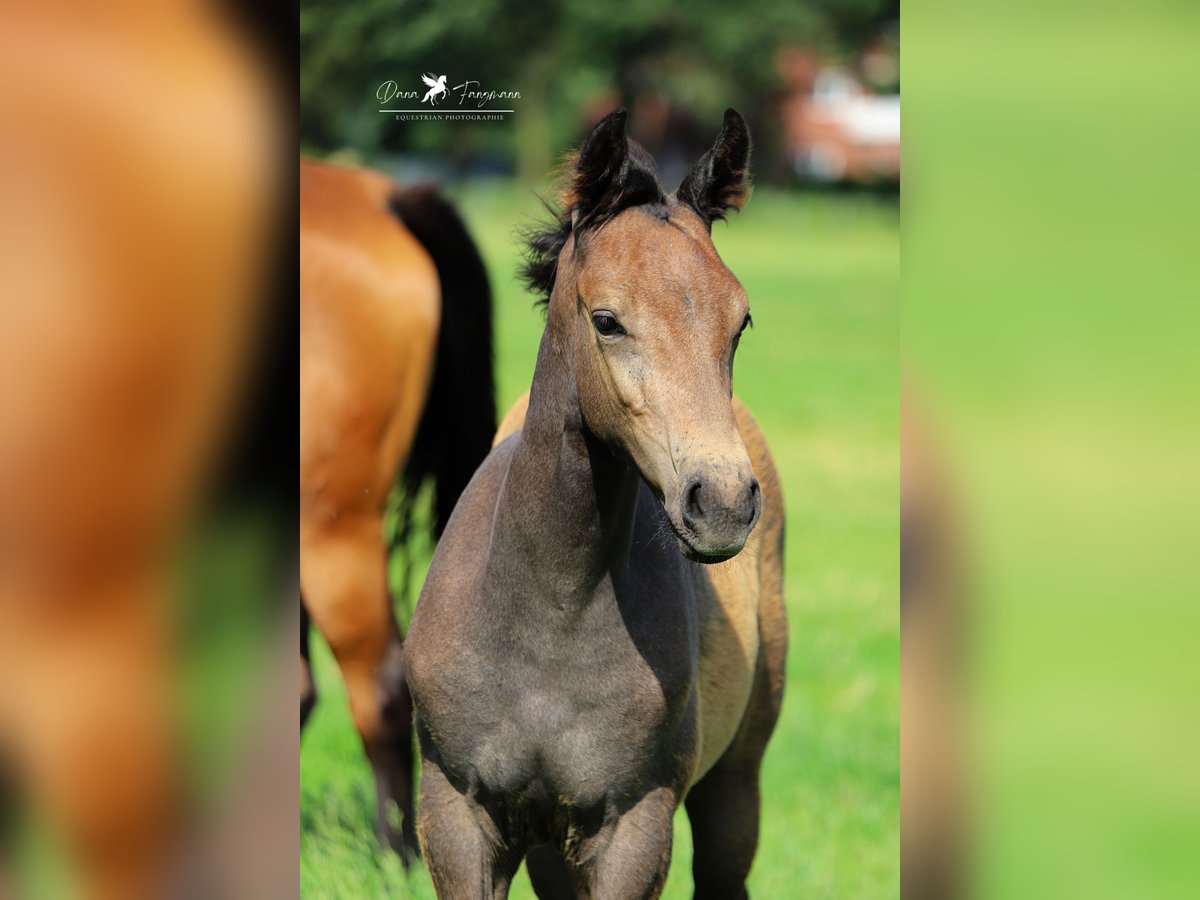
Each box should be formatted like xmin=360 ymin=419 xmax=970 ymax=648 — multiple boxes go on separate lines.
xmin=300 ymin=161 xmax=496 ymax=862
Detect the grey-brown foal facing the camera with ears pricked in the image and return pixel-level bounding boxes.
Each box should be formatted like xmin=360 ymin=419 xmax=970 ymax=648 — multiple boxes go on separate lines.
xmin=407 ymin=110 xmax=787 ymax=900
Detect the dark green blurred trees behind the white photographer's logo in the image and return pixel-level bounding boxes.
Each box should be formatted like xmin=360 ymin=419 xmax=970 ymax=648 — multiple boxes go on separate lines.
xmin=300 ymin=0 xmax=899 ymax=180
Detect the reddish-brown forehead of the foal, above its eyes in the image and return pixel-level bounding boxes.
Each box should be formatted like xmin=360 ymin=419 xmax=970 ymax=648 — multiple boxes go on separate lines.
xmin=581 ymin=204 xmax=745 ymax=304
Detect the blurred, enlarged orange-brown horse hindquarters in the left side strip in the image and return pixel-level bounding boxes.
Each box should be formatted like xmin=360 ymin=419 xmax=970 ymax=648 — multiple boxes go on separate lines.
xmin=0 ymin=8 xmax=277 ymax=900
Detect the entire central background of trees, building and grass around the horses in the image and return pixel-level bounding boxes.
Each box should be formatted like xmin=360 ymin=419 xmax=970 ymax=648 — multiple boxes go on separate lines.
xmin=300 ymin=0 xmax=900 ymax=899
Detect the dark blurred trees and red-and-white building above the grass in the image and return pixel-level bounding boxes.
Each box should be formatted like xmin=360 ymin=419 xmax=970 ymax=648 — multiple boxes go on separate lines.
xmin=300 ymin=0 xmax=900 ymax=190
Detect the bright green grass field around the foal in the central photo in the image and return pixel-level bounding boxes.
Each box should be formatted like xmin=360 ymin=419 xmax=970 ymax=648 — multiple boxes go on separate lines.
xmin=300 ymin=185 xmax=900 ymax=900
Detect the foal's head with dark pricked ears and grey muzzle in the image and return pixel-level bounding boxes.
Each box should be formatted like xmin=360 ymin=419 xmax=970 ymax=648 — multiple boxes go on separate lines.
xmin=526 ymin=109 xmax=761 ymax=562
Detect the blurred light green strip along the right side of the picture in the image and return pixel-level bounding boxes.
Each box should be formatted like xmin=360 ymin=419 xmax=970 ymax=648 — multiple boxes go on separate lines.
xmin=901 ymin=2 xmax=1200 ymax=900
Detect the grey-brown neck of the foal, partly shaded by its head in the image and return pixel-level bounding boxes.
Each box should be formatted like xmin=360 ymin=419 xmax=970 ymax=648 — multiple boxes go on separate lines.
xmin=490 ymin=328 xmax=638 ymax=610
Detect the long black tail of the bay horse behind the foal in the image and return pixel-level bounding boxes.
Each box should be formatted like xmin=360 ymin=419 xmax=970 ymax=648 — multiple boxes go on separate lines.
xmin=390 ymin=185 xmax=496 ymax=556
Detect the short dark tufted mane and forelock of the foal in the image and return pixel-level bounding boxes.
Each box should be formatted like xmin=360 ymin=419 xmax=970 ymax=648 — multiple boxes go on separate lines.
xmin=520 ymin=140 xmax=667 ymax=306
